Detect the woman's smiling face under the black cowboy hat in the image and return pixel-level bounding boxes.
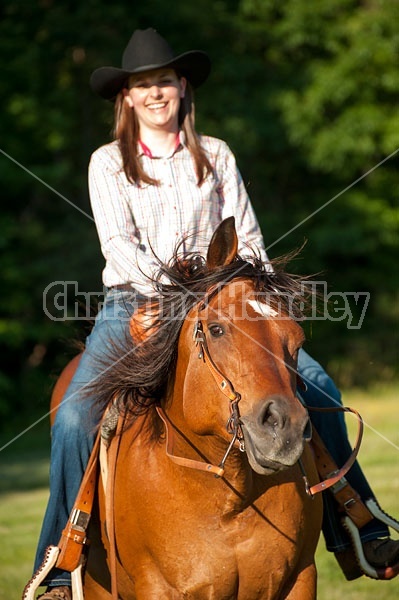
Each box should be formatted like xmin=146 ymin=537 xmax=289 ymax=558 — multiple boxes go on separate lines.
xmin=124 ymin=69 xmax=186 ymax=135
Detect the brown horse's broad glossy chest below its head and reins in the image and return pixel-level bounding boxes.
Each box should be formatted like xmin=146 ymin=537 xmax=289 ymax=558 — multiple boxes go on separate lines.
xmin=108 ymin=426 xmax=318 ymax=600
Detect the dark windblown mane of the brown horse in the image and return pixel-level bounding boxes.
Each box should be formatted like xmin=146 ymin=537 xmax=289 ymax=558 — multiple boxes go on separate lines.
xmin=88 ymin=248 xmax=306 ymax=416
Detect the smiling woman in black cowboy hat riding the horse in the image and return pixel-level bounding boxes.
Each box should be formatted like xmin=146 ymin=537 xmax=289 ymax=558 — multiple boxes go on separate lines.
xmin=36 ymin=29 xmax=399 ymax=600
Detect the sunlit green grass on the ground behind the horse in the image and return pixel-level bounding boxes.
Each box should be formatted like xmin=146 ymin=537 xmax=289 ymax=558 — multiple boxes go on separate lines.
xmin=0 ymin=386 xmax=399 ymax=600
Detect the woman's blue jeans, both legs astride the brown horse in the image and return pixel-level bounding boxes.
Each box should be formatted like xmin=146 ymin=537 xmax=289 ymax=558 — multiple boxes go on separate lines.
xmin=35 ymin=300 xmax=388 ymax=586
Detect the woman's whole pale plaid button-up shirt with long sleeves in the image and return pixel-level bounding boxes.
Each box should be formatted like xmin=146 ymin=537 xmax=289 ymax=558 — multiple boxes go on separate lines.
xmin=89 ymin=135 xmax=268 ymax=295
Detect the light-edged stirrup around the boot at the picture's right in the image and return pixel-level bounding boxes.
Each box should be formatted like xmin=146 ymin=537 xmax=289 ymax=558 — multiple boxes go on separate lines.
xmin=342 ymin=498 xmax=399 ymax=580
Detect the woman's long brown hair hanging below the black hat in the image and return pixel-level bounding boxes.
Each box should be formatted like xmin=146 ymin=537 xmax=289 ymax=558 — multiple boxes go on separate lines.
xmin=113 ymin=75 xmax=213 ymax=186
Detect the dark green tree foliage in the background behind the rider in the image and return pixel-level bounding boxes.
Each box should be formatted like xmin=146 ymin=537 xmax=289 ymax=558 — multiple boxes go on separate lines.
xmin=0 ymin=0 xmax=399 ymax=427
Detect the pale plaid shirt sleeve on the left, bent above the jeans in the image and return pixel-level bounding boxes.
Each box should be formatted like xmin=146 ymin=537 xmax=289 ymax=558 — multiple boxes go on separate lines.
xmin=89 ymin=148 xmax=159 ymax=296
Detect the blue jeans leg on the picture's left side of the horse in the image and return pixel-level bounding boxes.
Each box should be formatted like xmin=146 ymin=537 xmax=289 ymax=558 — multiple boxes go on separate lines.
xmin=34 ymin=290 xmax=135 ymax=586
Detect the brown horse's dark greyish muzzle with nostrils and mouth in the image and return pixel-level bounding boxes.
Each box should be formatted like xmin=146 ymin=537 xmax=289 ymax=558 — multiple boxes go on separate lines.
xmin=240 ymin=395 xmax=311 ymax=475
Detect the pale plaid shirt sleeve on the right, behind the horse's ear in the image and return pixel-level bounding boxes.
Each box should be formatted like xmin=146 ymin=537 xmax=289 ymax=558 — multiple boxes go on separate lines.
xmin=217 ymin=144 xmax=269 ymax=263
